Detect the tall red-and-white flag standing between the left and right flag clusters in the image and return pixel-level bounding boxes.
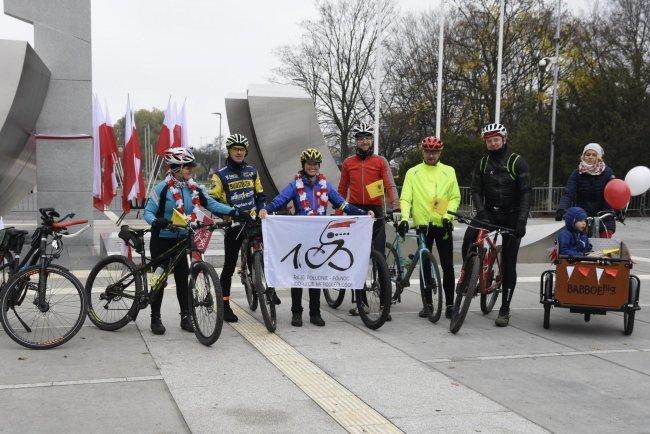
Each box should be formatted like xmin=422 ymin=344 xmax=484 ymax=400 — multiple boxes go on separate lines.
xmin=122 ymin=97 xmax=145 ymax=213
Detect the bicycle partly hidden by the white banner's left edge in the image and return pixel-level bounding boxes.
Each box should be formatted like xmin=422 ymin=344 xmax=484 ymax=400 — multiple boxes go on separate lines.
xmin=239 ymin=219 xmax=277 ymax=333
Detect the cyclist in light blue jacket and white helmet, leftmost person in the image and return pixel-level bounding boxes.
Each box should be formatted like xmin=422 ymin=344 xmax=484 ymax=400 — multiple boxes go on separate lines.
xmin=144 ymin=148 xmax=242 ymax=335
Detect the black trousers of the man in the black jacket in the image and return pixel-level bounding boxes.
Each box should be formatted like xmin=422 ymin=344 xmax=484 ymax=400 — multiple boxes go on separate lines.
xmin=463 ymin=213 xmax=521 ymax=309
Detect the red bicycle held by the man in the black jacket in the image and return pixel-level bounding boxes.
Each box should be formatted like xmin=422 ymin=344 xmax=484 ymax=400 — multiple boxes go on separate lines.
xmin=448 ymin=212 xmax=512 ymax=334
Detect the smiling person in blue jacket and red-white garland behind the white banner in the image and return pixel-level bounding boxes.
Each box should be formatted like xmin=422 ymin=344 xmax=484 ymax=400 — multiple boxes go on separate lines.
xmin=260 ymin=148 xmax=374 ymax=327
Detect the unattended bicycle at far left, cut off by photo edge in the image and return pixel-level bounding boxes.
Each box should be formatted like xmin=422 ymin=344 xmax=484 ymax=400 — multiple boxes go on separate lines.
xmin=0 ymin=208 xmax=90 ymax=350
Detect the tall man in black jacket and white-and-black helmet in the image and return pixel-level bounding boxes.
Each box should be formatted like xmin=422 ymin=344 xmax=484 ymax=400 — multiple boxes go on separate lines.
xmin=463 ymin=124 xmax=532 ymax=327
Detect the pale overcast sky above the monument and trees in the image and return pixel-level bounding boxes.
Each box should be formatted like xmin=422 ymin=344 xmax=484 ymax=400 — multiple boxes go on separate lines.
xmin=0 ymin=0 xmax=594 ymax=145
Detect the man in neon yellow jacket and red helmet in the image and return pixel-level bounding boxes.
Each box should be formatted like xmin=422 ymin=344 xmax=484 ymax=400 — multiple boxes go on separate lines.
xmin=397 ymin=136 xmax=460 ymax=318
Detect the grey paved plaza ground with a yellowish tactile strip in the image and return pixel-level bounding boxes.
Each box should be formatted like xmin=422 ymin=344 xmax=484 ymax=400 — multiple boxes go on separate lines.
xmin=0 ymin=218 xmax=650 ymax=433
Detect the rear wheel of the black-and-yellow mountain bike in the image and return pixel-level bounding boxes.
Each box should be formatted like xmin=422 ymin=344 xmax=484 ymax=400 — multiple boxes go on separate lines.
xmin=86 ymin=255 xmax=142 ymax=331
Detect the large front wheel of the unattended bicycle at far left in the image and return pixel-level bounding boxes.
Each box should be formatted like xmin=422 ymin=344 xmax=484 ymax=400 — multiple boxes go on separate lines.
xmin=0 ymin=265 xmax=88 ymax=350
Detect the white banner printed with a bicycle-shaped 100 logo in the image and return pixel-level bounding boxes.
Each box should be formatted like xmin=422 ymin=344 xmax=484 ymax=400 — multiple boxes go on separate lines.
xmin=262 ymin=216 xmax=374 ymax=289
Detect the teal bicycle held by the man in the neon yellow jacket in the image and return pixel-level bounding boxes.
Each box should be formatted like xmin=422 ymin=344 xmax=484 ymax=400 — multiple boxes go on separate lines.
xmin=386 ymin=214 xmax=443 ymax=323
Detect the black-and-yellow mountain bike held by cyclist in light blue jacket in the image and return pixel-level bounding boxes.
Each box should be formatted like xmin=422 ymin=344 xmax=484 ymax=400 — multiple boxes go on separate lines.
xmin=86 ymin=222 xmax=230 ymax=346
